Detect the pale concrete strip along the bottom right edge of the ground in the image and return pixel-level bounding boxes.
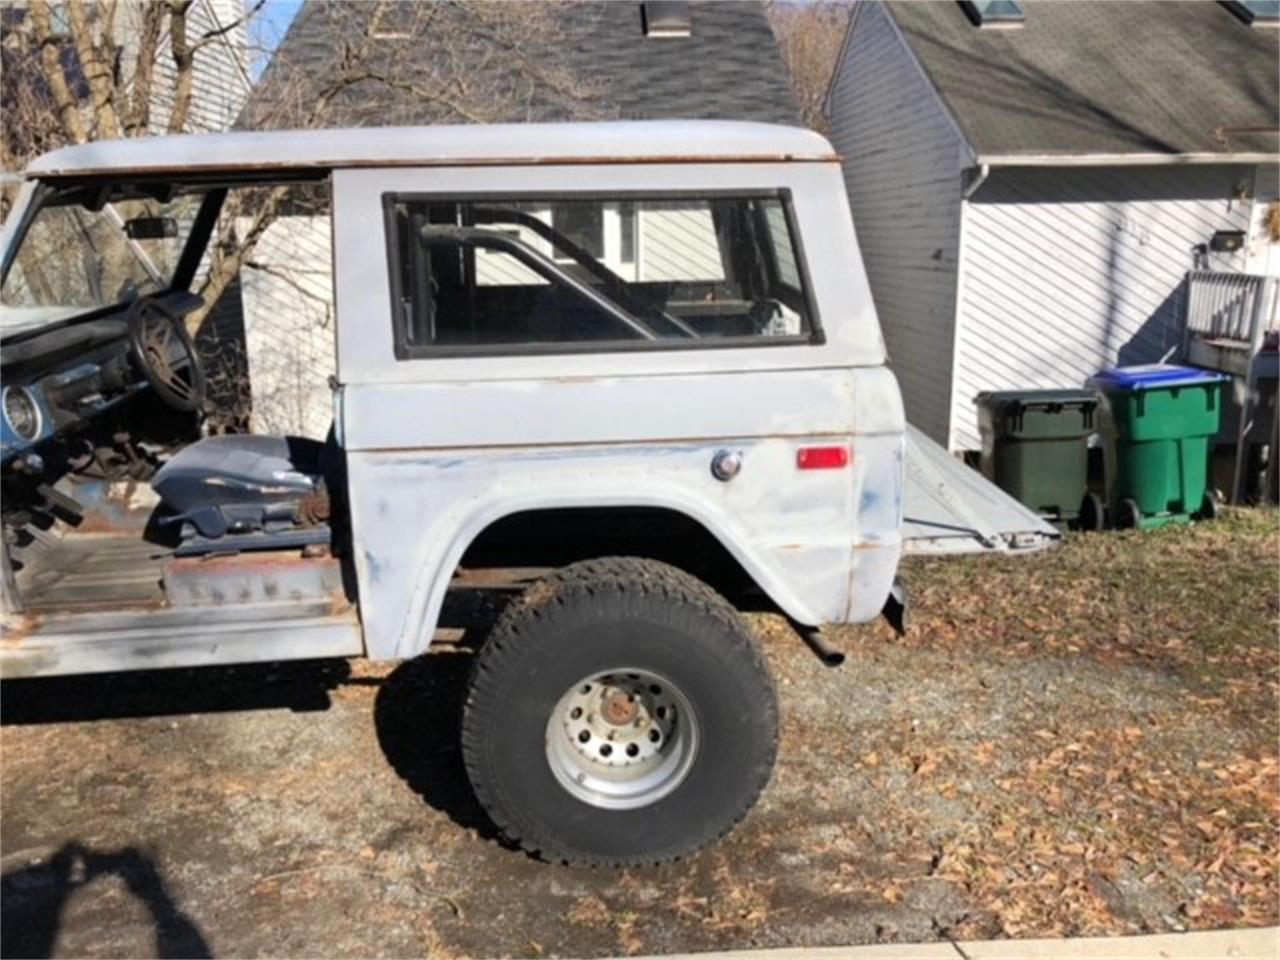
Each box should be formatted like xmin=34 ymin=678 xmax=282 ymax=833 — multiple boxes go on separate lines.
xmin=652 ymin=927 xmax=1280 ymax=960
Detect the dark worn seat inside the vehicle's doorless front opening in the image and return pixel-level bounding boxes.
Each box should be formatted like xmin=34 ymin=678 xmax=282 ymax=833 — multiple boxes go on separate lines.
xmin=151 ymin=434 xmax=326 ymax=538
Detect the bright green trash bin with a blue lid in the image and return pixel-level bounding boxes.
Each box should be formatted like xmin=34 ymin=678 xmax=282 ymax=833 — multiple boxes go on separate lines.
xmin=1089 ymin=364 xmax=1228 ymax=529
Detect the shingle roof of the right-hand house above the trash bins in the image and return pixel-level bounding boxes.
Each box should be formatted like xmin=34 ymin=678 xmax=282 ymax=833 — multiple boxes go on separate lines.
xmin=890 ymin=0 xmax=1280 ymax=155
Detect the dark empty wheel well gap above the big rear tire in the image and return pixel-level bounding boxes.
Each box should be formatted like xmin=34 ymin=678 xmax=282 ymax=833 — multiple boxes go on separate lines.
xmin=460 ymin=507 xmax=769 ymax=608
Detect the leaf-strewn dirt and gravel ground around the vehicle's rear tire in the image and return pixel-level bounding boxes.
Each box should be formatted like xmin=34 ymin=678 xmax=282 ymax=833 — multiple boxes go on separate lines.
xmin=0 ymin=512 xmax=1280 ymax=956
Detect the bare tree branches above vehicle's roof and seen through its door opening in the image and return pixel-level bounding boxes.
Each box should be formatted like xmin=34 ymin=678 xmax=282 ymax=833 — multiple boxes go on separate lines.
xmin=0 ymin=0 xmax=608 ymax=433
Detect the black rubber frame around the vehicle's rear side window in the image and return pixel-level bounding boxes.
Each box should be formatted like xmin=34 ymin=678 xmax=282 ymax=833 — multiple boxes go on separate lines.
xmin=381 ymin=187 xmax=827 ymax=361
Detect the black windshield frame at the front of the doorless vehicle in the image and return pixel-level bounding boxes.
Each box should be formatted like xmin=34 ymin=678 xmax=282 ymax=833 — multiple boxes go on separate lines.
xmin=0 ymin=179 xmax=227 ymax=342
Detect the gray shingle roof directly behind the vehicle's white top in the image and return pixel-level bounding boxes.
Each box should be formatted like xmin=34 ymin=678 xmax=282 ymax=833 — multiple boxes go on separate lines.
xmin=239 ymin=0 xmax=800 ymax=127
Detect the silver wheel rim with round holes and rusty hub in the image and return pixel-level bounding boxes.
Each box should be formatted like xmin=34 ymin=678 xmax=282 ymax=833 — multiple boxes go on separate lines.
xmin=545 ymin=667 xmax=698 ymax=810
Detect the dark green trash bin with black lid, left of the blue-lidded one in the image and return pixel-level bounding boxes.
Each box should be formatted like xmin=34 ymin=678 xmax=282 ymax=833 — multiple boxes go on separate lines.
xmin=974 ymin=389 xmax=1103 ymax=530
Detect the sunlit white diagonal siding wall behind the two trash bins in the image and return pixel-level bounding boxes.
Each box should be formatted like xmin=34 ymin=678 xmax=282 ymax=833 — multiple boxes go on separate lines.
xmin=951 ymin=166 xmax=1254 ymax=449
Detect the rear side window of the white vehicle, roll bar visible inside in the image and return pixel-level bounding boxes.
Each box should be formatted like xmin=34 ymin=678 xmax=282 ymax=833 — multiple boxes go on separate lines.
xmin=387 ymin=193 xmax=815 ymax=358
